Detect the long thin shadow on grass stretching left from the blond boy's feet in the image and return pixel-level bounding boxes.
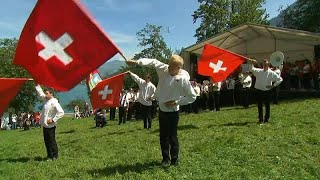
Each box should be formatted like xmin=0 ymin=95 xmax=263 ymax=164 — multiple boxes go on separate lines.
xmin=88 ymin=161 xmax=160 ymax=177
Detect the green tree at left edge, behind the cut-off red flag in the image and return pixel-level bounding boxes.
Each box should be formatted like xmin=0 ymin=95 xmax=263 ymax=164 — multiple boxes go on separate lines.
xmin=0 ymin=39 xmax=37 ymax=113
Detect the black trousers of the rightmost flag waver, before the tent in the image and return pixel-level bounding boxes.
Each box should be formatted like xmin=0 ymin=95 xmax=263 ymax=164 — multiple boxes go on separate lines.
xmin=257 ymin=90 xmax=272 ymax=122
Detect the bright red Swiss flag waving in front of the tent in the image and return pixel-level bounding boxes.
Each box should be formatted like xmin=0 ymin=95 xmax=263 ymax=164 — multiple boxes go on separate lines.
xmin=198 ymin=44 xmax=245 ymax=82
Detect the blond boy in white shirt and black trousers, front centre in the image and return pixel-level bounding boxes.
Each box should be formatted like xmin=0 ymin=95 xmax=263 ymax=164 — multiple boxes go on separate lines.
xmin=127 ymin=55 xmax=197 ymax=167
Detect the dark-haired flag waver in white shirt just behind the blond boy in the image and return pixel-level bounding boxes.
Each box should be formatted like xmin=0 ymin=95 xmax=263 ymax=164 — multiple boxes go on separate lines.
xmin=127 ymin=71 xmax=156 ymax=129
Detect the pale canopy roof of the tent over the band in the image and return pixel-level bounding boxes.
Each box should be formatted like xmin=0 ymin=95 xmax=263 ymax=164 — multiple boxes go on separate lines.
xmin=182 ymin=24 xmax=320 ymax=72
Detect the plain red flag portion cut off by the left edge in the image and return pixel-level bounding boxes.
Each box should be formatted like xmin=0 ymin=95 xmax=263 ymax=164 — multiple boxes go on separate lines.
xmin=0 ymin=78 xmax=29 ymax=117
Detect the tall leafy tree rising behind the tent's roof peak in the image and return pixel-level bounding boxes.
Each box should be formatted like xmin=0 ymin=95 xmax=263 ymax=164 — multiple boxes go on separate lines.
xmin=192 ymin=0 xmax=268 ymax=42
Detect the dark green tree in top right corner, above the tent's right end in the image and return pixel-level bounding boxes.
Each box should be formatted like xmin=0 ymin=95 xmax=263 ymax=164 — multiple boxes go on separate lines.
xmin=278 ymin=0 xmax=320 ymax=32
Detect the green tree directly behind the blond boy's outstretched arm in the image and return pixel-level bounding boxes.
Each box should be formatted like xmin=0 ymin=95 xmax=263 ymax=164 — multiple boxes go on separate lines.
xmin=123 ymin=23 xmax=172 ymax=88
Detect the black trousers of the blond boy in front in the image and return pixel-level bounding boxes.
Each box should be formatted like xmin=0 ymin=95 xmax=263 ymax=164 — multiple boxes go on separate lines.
xmin=159 ymin=110 xmax=179 ymax=161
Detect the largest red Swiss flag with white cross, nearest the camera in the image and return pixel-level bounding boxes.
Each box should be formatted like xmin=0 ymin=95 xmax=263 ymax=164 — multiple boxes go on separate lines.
xmin=14 ymin=0 xmax=121 ymax=91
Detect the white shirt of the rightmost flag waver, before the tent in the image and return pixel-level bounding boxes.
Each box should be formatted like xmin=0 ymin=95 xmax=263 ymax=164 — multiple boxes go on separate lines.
xmin=250 ymin=65 xmax=283 ymax=91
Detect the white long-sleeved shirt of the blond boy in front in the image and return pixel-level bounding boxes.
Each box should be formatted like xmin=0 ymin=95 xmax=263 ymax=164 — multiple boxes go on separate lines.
xmin=137 ymin=58 xmax=197 ymax=112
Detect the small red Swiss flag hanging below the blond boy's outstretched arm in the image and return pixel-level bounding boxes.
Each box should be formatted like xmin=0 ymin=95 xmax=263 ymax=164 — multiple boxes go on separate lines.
xmin=90 ymin=73 xmax=125 ymax=109
